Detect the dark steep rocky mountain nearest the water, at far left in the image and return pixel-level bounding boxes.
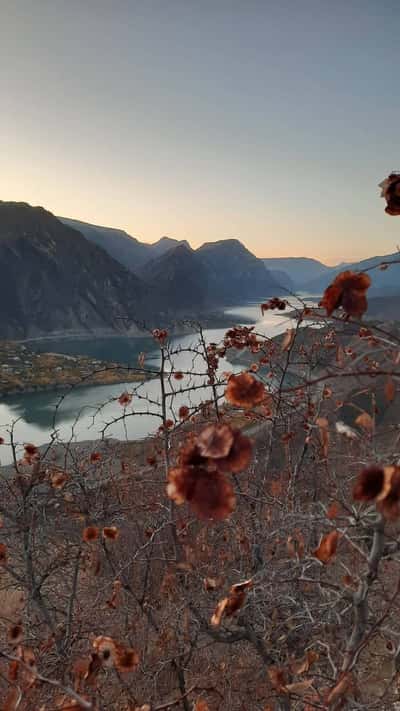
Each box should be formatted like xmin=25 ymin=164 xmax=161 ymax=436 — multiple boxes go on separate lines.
xmin=0 ymin=201 xmax=151 ymax=338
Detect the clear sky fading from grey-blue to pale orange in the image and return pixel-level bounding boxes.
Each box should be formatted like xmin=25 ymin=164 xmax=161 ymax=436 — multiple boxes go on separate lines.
xmin=0 ymin=0 xmax=400 ymax=264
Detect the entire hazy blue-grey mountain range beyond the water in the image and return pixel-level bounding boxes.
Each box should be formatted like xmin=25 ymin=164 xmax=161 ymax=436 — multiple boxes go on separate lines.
xmin=0 ymin=201 xmax=400 ymax=339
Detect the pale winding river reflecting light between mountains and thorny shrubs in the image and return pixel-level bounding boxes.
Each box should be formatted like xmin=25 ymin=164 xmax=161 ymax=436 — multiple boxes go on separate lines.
xmin=0 ymin=301 xmax=312 ymax=464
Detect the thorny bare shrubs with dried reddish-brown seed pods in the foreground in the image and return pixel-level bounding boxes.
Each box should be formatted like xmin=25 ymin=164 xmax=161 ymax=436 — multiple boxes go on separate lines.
xmin=0 ymin=176 xmax=400 ymax=711
